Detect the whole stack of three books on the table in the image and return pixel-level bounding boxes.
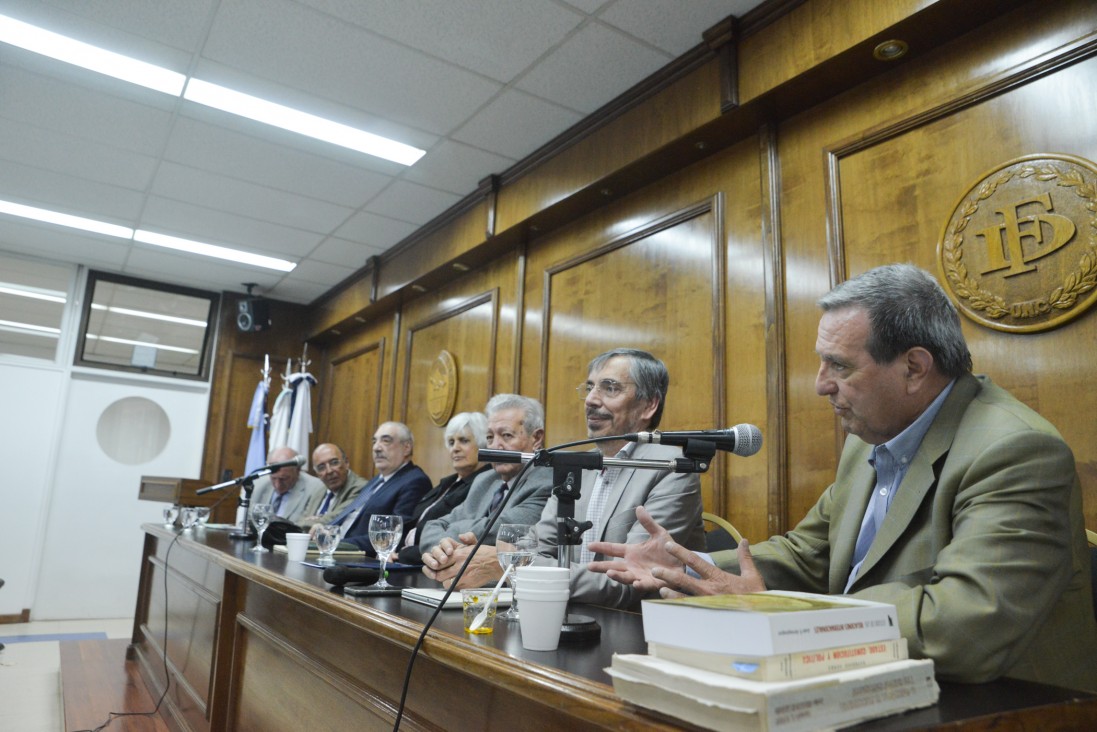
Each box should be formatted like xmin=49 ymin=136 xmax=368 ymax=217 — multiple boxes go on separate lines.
xmin=606 ymin=592 xmax=938 ymax=732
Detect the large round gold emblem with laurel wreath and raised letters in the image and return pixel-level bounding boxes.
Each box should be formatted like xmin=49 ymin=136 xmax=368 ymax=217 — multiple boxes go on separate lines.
xmin=937 ymin=154 xmax=1097 ymax=333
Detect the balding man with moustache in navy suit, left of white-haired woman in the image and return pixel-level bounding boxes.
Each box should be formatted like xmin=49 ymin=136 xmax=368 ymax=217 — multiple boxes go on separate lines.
xmin=330 ymin=421 xmax=431 ymax=551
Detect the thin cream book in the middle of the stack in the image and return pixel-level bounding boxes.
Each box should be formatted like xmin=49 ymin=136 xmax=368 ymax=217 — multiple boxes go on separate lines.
xmin=647 ymin=638 xmax=907 ymax=682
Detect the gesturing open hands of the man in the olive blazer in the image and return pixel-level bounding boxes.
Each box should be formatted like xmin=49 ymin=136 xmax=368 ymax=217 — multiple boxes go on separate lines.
xmin=589 ymin=506 xmax=766 ymax=597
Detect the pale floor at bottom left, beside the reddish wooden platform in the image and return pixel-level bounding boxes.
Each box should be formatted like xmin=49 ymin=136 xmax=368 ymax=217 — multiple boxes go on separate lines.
xmin=0 ymin=619 xmax=133 ymax=732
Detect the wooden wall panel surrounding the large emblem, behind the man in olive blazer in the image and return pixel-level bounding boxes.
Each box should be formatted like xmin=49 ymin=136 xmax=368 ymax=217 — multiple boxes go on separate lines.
xmin=779 ymin=2 xmax=1097 ymax=525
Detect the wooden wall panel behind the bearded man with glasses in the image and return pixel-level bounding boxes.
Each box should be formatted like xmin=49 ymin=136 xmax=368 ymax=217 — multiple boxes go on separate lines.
xmin=522 ymin=139 xmax=768 ymax=537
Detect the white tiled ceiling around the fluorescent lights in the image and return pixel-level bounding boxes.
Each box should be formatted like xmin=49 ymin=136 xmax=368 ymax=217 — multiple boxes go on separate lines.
xmin=0 ymin=0 xmax=760 ymax=303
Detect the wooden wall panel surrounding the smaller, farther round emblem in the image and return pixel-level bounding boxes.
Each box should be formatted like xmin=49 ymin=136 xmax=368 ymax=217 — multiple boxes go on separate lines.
xmin=395 ymin=290 xmax=499 ymax=483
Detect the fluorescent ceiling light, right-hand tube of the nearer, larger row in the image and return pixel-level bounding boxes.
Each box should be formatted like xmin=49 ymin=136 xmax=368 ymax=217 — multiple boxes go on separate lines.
xmin=183 ymin=79 xmax=427 ymax=166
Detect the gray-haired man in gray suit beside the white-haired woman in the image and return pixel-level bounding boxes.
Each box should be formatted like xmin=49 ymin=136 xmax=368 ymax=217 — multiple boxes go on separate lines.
xmin=419 ymin=394 xmax=552 ymax=587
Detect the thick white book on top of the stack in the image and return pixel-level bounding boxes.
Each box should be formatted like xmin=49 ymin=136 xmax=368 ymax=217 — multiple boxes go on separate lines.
xmin=642 ymin=590 xmax=900 ymax=656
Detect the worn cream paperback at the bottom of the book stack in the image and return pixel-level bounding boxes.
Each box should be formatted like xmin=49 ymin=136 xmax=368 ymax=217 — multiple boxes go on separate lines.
xmin=606 ymin=654 xmax=939 ymax=732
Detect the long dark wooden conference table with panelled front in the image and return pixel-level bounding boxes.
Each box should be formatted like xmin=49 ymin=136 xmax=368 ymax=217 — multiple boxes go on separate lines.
xmin=131 ymin=525 xmax=1097 ymax=732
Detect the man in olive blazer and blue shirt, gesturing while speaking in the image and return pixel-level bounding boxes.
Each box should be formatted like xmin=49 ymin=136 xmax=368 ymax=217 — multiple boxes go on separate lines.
xmin=591 ymin=264 xmax=1097 ymax=690
